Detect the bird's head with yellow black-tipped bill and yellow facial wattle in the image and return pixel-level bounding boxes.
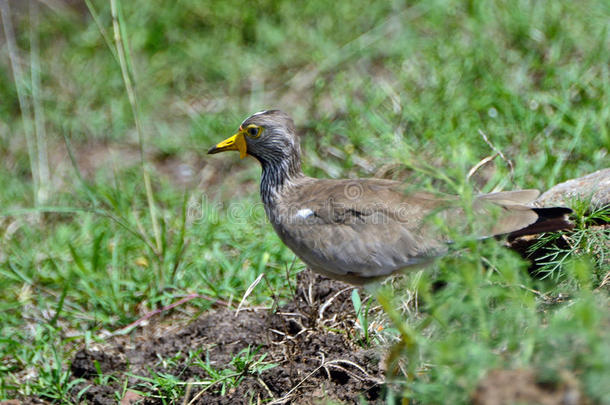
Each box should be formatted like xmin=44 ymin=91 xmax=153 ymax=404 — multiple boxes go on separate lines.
xmin=208 ymin=110 xmax=301 ymax=164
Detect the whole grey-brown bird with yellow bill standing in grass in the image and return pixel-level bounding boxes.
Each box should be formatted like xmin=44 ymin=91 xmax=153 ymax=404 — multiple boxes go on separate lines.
xmin=208 ymin=110 xmax=572 ymax=286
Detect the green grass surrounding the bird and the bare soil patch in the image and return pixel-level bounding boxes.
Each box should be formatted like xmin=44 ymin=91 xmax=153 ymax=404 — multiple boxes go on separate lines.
xmin=0 ymin=0 xmax=610 ymax=403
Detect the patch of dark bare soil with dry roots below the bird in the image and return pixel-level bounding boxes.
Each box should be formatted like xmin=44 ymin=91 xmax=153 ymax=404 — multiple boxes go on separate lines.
xmin=65 ymin=272 xmax=383 ymax=405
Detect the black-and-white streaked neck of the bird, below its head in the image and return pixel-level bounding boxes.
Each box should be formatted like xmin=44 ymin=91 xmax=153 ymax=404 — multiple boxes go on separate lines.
xmin=260 ymin=154 xmax=305 ymax=206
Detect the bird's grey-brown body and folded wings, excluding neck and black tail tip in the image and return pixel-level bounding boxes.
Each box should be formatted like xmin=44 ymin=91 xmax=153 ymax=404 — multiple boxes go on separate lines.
xmin=271 ymin=179 xmax=538 ymax=279
